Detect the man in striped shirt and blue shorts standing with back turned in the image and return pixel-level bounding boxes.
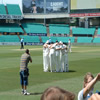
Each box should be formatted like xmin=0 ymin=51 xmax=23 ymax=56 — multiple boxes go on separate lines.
xmin=20 ymin=49 xmax=32 ymax=95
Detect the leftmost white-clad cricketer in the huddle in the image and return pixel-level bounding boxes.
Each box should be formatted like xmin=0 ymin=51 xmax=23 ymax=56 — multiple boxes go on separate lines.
xmin=43 ymin=40 xmax=50 ymax=72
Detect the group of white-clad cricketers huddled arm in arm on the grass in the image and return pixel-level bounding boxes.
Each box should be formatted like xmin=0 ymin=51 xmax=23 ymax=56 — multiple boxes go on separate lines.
xmin=43 ymin=40 xmax=71 ymax=72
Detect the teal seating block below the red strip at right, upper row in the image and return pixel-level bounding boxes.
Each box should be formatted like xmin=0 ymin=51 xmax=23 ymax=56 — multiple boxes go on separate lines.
xmin=72 ymin=27 xmax=95 ymax=36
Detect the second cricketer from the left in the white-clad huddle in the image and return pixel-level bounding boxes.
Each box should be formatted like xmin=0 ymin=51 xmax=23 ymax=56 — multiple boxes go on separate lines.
xmin=49 ymin=43 xmax=55 ymax=72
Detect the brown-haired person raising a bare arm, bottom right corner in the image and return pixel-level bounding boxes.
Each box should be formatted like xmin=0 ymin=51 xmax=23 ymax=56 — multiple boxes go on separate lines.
xmin=78 ymin=72 xmax=100 ymax=100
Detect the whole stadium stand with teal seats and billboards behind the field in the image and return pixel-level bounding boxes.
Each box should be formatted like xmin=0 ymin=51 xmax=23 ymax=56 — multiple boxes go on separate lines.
xmin=0 ymin=0 xmax=100 ymax=45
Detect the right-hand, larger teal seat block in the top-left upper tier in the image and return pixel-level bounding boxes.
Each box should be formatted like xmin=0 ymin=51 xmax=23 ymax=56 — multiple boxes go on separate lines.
xmin=6 ymin=4 xmax=22 ymax=15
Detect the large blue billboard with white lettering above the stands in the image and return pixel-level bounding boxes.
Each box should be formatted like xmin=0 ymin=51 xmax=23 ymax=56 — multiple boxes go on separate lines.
xmin=23 ymin=0 xmax=69 ymax=14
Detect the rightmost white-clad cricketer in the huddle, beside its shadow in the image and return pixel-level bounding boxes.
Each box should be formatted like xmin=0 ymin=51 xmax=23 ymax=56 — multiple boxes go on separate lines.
xmin=60 ymin=41 xmax=69 ymax=72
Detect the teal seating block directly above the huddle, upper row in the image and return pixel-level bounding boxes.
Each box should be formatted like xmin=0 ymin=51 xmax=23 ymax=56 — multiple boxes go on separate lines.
xmin=49 ymin=24 xmax=70 ymax=35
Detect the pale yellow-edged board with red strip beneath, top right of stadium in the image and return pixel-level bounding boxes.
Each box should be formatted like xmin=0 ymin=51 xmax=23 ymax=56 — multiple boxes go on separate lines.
xmin=70 ymin=0 xmax=100 ymax=17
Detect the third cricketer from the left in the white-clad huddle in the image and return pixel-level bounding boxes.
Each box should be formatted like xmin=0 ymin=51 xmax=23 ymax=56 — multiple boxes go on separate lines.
xmin=55 ymin=41 xmax=61 ymax=72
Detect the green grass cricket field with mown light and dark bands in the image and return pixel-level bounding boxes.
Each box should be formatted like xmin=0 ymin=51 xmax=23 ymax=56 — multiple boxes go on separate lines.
xmin=0 ymin=46 xmax=100 ymax=100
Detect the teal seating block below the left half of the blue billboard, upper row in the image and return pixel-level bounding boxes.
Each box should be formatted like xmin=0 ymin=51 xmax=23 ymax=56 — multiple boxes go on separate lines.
xmin=22 ymin=23 xmax=47 ymax=36
